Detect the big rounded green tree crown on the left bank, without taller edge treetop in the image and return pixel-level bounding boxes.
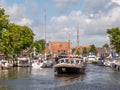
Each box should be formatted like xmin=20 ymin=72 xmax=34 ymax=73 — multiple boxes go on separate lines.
xmin=0 ymin=24 xmax=34 ymax=56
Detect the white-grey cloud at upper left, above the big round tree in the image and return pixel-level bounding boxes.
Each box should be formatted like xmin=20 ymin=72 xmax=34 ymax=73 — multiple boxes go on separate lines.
xmin=0 ymin=0 xmax=38 ymax=26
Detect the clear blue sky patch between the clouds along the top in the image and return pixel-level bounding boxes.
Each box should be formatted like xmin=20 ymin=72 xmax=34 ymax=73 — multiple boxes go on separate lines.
xmin=5 ymin=0 xmax=85 ymax=23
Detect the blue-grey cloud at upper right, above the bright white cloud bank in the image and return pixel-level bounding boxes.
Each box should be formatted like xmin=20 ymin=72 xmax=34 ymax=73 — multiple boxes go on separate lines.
xmin=83 ymin=0 xmax=117 ymax=17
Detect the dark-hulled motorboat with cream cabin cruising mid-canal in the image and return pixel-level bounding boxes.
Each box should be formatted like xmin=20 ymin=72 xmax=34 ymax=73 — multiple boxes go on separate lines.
xmin=54 ymin=58 xmax=86 ymax=74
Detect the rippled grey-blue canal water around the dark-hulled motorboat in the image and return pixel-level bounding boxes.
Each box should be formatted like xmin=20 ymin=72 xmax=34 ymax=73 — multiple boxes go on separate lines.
xmin=0 ymin=64 xmax=120 ymax=90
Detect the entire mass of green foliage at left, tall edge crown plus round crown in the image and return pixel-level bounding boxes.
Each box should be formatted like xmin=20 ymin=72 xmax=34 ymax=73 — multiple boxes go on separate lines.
xmin=0 ymin=8 xmax=34 ymax=56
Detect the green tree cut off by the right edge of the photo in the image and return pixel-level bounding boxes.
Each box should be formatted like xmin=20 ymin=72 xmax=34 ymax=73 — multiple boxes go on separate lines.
xmin=107 ymin=27 xmax=120 ymax=53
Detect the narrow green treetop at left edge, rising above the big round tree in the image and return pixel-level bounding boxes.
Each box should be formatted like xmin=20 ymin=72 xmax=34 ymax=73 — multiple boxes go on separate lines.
xmin=0 ymin=8 xmax=9 ymax=39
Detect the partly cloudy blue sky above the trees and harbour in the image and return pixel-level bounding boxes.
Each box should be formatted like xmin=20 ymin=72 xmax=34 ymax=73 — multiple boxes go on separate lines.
xmin=0 ymin=0 xmax=120 ymax=47
